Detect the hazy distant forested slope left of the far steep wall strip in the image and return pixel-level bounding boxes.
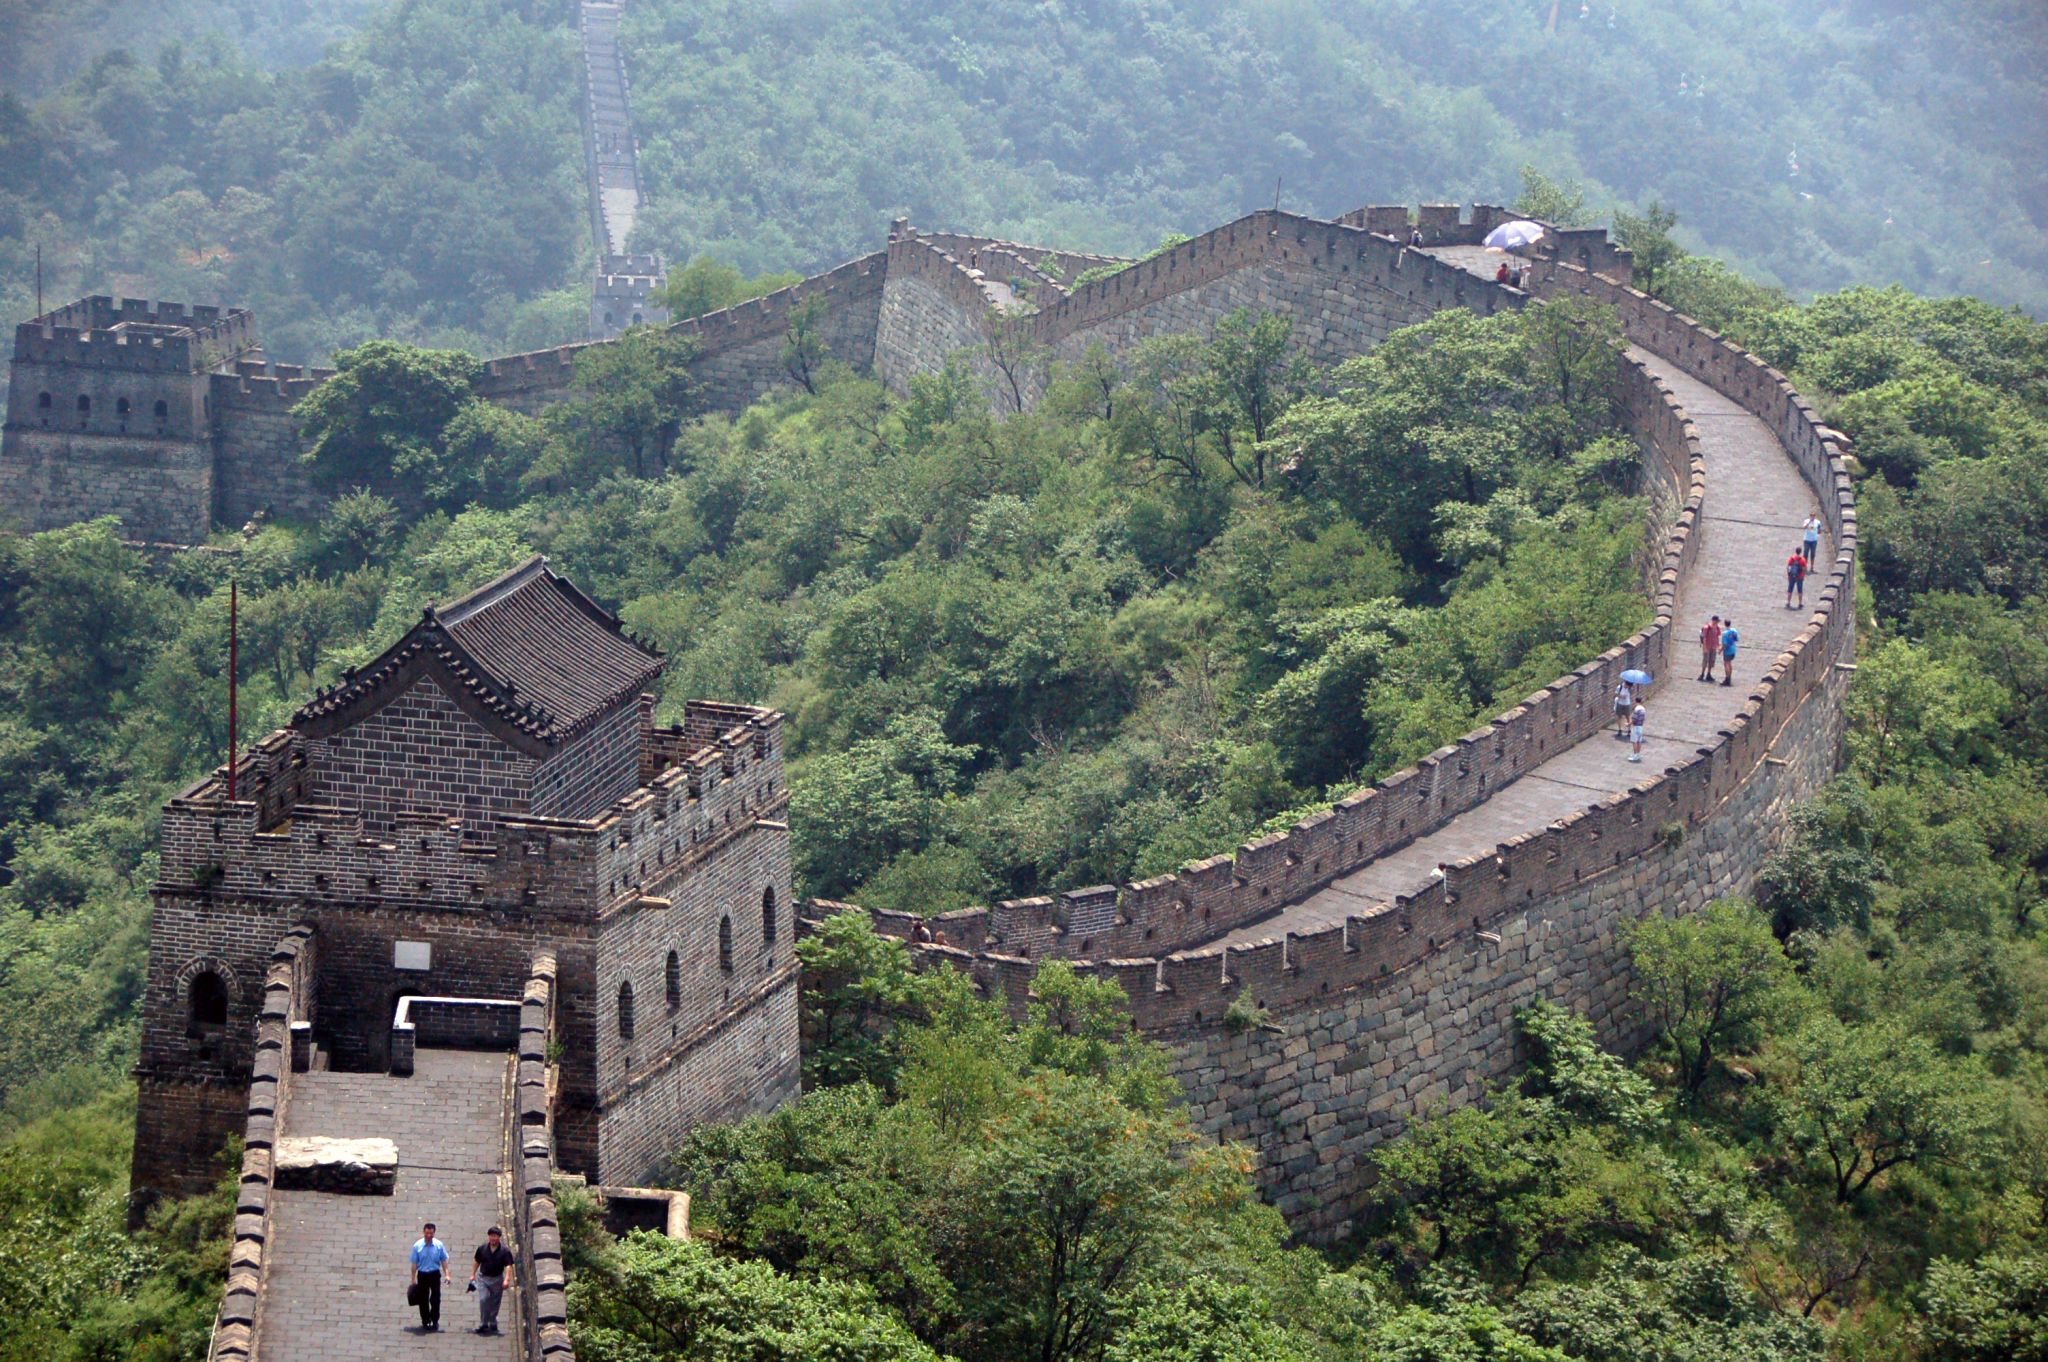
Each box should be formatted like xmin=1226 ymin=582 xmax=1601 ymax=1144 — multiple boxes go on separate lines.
xmin=0 ymin=0 xmax=588 ymax=360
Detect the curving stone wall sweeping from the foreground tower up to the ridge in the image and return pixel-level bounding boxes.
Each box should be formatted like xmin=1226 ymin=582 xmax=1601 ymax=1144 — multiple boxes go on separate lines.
xmin=811 ymin=213 xmax=1858 ymax=1237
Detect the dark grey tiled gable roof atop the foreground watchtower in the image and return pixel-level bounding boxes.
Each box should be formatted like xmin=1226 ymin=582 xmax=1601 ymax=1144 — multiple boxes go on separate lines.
xmin=293 ymin=555 xmax=664 ymax=746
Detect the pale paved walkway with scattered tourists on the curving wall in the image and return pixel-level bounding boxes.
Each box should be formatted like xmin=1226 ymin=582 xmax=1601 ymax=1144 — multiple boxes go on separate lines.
xmin=1212 ymin=333 xmax=1833 ymax=944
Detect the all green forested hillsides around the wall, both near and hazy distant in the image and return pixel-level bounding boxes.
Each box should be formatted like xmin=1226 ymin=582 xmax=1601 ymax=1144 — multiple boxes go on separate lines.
xmin=0 ymin=0 xmax=2048 ymax=1362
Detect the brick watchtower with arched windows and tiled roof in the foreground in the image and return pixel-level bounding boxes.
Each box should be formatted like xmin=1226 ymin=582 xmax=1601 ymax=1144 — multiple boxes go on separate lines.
xmin=133 ymin=557 xmax=799 ymax=1196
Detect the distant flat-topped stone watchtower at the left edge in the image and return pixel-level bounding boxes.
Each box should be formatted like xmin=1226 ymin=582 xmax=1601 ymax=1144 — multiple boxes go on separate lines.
xmin=0 ymin=297 xmax=256 ymax=543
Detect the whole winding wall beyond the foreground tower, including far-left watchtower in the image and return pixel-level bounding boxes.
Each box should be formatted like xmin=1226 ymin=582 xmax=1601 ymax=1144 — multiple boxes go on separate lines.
xmin=0 ymin=207 xmax=1855 ymax=1233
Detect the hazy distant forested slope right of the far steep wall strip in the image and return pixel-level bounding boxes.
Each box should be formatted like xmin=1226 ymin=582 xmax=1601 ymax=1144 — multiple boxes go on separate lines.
xmin=627 ymin=0 xmax=2048 ymax=311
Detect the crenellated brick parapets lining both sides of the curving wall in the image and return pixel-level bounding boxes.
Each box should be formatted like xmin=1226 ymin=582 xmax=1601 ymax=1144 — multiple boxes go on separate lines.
xmin=807 ymin=244 xmax=1858 ymax=1056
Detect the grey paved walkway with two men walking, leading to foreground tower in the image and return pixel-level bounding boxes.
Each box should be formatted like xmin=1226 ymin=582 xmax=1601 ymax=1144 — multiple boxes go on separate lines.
xmin=258 ymin=1051 xmax=522 ymax=1362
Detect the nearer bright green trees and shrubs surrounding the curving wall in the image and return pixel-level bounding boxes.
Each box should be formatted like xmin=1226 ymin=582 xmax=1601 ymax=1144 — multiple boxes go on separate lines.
xmin=0 ymin=241 xmax=2048 ymax=1362
